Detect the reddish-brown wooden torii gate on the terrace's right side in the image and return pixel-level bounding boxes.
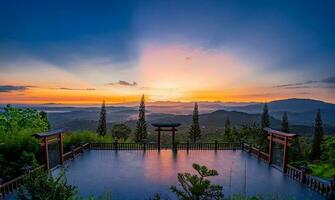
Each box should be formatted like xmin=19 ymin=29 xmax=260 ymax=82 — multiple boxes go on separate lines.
xmin=264 ymin=128 xmax=296 ymax=172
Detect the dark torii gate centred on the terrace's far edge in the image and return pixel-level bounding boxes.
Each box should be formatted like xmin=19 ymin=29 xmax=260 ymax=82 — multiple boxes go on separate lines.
xmin=152 ymin=123 xmax=181 ymax=151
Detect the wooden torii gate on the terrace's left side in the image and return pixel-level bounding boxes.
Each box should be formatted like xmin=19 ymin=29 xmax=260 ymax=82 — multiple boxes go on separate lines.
xmin=34 ymin=129 xmax=64 ymax=169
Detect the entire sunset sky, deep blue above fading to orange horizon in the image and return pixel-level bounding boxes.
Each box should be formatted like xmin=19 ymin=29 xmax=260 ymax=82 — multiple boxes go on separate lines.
xmin=0 ymin=0 xmax=335 ymax=104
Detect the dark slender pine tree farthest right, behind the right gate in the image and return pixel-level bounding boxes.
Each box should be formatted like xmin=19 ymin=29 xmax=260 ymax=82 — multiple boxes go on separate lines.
xmin=310 ymin=109 xmax=323 ymax=160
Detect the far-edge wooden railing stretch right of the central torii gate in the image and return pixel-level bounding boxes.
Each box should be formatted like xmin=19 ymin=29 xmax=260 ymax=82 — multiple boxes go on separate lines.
xmin=176 ymin=142 xmax=241 ymax=150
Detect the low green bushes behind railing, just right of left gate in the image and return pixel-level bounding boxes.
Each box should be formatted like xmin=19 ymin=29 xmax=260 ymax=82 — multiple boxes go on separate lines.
xmin=63 ymin=130 xmax=112 ymax=152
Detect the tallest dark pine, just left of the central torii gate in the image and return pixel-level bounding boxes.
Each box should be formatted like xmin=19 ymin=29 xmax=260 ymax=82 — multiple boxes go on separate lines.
xmin=135 ymin=95 xmax=148 ymax=142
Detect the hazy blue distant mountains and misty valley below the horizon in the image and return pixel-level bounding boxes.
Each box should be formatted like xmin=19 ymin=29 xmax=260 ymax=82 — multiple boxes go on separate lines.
xmin=1 ymin=99 xmax=335 ymax=135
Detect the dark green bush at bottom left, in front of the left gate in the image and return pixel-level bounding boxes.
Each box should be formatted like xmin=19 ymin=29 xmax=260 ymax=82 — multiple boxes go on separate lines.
xmin=18 ymin=170 xmax=77 ymax=200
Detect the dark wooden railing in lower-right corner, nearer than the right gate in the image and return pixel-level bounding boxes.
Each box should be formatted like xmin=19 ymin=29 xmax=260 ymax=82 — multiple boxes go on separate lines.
xmin=286 ymin=165 xmax=335 ymax=196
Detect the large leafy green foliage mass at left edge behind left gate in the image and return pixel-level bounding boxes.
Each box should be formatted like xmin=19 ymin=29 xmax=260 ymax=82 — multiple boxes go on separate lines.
xmin=0 ymin=105 xmax=48 ymax=181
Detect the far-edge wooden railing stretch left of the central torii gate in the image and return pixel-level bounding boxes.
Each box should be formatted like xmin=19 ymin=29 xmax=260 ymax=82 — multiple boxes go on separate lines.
xmin=90 ymin=142 xmax=158 ymax=150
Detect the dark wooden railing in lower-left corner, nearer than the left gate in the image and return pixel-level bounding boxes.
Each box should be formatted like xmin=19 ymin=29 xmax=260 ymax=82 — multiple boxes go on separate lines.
xmin=0 ymin=165 xmax=46 ymax=199
